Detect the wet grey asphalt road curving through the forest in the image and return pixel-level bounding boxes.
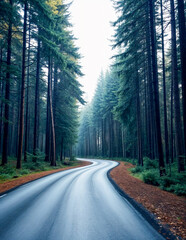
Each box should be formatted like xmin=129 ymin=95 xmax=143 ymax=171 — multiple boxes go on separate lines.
xmin=0 ymin=160 xmax=164 ymax=240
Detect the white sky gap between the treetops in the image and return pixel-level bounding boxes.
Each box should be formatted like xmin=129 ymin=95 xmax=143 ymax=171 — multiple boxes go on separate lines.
xmin=69 ymin=0 xmax=116 ymax=102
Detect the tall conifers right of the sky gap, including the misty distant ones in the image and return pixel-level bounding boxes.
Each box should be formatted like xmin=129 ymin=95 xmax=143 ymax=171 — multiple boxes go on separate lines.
xmin=77 ymin=0 xmax=186 ymax=176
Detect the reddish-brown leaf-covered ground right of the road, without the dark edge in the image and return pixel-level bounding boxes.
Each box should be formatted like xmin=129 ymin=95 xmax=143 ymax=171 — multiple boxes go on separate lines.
xmin=110 ymin=162 xmax=186 ymax=239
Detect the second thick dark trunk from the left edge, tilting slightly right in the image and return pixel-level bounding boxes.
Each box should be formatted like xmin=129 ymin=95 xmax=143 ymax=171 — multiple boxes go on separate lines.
xmin=17 ymin=1 xmax=28 ymax=169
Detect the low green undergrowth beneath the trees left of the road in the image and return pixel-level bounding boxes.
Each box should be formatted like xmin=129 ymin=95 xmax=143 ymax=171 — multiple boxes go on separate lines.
xmin=0 ymin=156 xmax=79 ymax=183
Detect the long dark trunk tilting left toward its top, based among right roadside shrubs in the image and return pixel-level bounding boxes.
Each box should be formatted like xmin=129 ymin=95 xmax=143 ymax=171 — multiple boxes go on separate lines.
xmin=149 ymin=0 xmax=165 ymax=176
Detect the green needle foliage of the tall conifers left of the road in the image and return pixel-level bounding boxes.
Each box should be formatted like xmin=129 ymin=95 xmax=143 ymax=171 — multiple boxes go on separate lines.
xmin=0 ymin=0 xmax=85 ymax=167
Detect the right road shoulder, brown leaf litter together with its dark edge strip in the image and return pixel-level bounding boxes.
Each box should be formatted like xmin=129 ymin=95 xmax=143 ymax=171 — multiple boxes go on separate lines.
xmin=108 ymin=162 xmax=186 ymax=239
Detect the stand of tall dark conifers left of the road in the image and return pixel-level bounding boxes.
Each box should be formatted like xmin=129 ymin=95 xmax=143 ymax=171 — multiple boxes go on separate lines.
xmin=0 ymin=0 xmax=84 ymax=168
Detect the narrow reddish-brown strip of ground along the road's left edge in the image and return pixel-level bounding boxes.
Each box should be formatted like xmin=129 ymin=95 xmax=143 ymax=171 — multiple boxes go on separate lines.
xmin=0 ymin=161 xmax=91 ymax=194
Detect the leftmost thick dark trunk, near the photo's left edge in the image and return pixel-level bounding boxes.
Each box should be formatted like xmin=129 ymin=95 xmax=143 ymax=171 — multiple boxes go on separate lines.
xmin=2 ymin=0 xmax=12 ymax=165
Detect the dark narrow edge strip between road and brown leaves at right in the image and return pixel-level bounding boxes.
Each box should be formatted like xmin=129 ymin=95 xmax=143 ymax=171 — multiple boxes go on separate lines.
xmin=107 ymin=162 xmax=182 ymax=240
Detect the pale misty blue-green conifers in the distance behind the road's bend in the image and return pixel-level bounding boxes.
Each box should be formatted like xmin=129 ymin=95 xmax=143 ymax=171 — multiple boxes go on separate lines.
xmin=77 ymin=69 xmax=120 ymax=157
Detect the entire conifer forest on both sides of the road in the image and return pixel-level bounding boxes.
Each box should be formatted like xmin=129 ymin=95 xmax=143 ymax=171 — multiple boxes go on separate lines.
xmin=0 ymin=0 xmax=186 ymax=193
